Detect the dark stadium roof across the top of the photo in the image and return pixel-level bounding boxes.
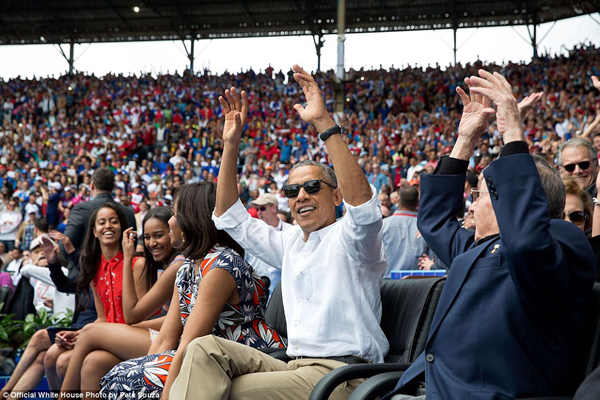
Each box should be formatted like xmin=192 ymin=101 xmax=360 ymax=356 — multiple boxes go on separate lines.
xmin=0 ymin=0 xmax=600 ymax=45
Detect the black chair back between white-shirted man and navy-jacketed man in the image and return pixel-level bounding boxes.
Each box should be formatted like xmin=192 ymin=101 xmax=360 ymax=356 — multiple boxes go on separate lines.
xmin=381 ymin=278 xmax=446 ymax=363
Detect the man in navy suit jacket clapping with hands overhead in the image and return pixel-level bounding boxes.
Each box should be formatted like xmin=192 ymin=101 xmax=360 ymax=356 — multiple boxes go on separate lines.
xmin=392 ymin=71 xmax=594 ymax=400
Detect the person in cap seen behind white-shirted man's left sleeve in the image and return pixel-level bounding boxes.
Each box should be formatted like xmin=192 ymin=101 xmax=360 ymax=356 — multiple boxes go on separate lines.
xmin=245 ymin=193 xmax=292 ymax=291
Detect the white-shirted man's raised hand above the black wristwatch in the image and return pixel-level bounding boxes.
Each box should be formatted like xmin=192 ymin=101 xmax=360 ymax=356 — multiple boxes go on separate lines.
xmin=292 ymin=64 xmax=334 ymax=132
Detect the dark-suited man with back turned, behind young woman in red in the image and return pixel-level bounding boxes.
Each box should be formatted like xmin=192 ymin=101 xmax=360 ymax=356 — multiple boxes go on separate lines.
xmin=65 ymin=168 xmax=136 ymax=249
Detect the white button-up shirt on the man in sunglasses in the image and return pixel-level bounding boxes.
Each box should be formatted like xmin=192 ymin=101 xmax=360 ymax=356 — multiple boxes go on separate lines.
xmin=213 ymin=187 xmax=389 ymax=362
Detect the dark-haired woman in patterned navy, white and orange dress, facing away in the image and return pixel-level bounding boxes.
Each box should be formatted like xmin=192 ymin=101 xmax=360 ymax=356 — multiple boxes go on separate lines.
xmin=100 ymin=182 xmax=284 ymax=398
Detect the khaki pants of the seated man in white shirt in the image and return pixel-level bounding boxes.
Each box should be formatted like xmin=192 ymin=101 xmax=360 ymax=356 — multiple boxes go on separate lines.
xmin=169 ymin=335 xmax=363 ymax=400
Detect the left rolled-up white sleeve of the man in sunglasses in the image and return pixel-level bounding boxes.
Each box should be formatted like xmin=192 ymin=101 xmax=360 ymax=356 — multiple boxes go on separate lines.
xmin=212 ymin=199 xmax=283 ymax=265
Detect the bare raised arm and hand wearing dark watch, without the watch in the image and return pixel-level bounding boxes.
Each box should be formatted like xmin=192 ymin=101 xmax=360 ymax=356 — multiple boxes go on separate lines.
xmin=293 ymin=65 xmax=373 ymax=206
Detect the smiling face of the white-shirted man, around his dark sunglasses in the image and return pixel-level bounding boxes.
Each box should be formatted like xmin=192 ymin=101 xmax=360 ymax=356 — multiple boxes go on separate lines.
xmin=288 ymin=165 xmax=342 ymax=240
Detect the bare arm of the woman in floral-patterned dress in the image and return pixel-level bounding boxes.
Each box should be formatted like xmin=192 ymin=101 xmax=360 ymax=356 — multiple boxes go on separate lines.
xmin=161 ymin=268 xmax=239 ymax=400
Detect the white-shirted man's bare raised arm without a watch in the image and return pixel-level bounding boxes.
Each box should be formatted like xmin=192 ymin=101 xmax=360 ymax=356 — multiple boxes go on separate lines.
xmin=215 ymin=88 xmax=248 ymax=217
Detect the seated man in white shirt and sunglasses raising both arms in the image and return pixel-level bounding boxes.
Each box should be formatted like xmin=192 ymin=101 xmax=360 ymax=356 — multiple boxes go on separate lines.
xmin=171 ymin=65 xmax=389 ymax=400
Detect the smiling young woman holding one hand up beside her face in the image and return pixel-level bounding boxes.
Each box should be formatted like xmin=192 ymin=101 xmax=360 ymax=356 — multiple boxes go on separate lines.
xmin=62 ymin=207 xmax=183 ymax=391
